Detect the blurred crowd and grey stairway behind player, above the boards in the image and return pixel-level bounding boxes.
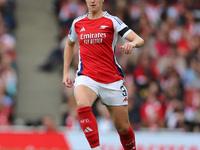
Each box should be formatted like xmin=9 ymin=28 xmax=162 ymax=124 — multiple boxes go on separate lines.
xmin=0 ymin=0 xmax=200 ymax=149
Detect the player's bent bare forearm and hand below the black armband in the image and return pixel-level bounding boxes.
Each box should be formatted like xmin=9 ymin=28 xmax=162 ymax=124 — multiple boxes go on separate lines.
xmin=120 ymin=30 xmax=144 ymax=55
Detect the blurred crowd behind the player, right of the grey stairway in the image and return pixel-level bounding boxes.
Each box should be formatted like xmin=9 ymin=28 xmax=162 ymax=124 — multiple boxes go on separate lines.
xmin=41 ymin=0 xmax=200 ymax=132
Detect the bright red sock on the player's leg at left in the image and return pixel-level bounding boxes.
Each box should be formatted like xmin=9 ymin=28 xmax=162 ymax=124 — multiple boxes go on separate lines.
xmin=78 ymin=106 xmax=100 ymax=148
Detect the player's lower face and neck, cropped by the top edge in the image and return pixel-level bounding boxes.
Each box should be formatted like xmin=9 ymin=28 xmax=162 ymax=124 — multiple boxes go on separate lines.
xmin=86 ymin=0 xmax=104 ymax=12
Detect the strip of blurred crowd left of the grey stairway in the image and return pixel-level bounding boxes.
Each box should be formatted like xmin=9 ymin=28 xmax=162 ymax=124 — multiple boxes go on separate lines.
xmin=0 ymin=0 xmax=18 ymax=126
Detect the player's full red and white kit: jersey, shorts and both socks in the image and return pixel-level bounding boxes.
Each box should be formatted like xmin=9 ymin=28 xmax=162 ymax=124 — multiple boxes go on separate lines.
xmin=68 ymin=12 xmax=135 ymax=150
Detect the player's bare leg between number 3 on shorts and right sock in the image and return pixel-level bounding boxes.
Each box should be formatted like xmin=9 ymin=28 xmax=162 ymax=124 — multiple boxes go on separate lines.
xmin=106 ymin=105 xmax=130 ymax=133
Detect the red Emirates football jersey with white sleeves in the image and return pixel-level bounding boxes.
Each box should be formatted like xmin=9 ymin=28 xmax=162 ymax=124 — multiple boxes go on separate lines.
xmin=68 ymin=12 xmax=131 ymax=83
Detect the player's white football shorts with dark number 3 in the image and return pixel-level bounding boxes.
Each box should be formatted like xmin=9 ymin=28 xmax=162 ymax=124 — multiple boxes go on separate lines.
xmin=74 ymin=75 xmax=128 ymax=106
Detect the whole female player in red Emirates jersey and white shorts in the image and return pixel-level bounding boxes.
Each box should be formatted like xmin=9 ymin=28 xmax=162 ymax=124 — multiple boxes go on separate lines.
xmin=63 ymin=0 xmax=144 ymax=150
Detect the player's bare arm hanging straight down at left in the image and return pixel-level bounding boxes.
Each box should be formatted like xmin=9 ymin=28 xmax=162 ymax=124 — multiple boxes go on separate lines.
xmin=63 ymin=38 xmax=75 ymax=87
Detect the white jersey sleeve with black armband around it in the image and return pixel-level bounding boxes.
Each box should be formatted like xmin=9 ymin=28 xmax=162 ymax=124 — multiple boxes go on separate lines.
xmin=113 ymin=17 xmax=132 ymax=38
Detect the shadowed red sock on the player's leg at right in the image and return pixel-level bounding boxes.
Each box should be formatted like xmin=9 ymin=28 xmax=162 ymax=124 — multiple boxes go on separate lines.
xmin=118 ymin=126 xmax=136 ymax=150
